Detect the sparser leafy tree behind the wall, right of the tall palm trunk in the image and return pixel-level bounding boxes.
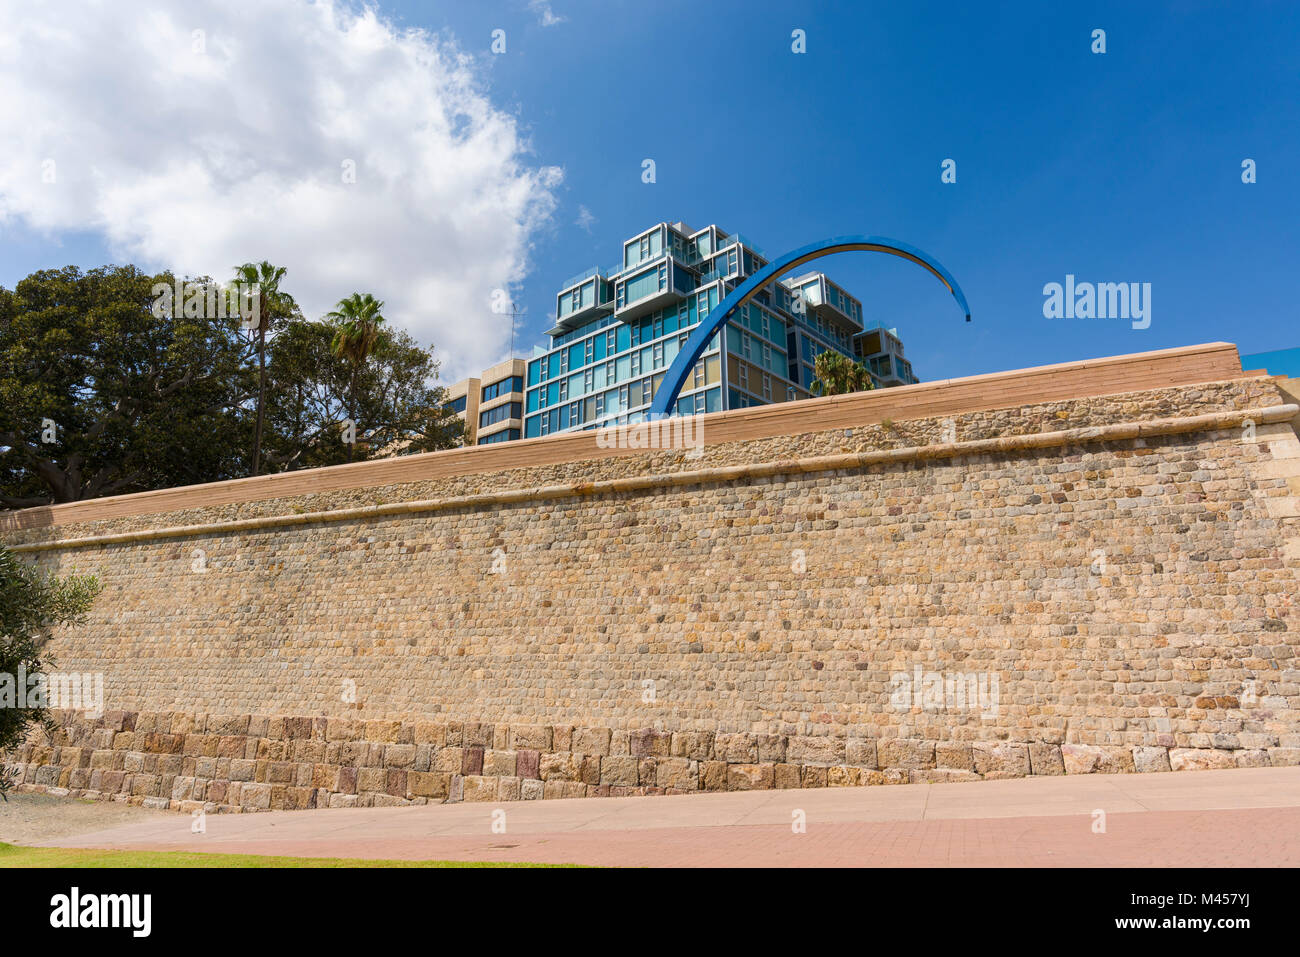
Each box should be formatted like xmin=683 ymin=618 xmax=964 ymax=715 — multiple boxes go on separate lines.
xmin=267 ymin=320 xmax=464 ymax=469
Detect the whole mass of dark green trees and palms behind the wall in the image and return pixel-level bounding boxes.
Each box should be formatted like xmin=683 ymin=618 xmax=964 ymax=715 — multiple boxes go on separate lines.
xmin=0 ymin=263 xmax=462 ymax=508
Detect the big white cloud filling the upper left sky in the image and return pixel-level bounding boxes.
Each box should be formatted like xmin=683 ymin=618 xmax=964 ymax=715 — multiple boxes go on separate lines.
xmin=0 ymin=0 xmax=560 ymax=377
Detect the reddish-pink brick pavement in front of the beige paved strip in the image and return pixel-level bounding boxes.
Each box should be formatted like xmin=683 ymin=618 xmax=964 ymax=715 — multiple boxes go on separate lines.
xmin=43 ymin=807 xmax=1300 ymax=867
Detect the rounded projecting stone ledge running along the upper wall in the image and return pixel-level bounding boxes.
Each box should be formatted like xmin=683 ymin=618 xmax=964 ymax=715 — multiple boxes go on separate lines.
xmin=9 ymin=404 xmax=1300 ymax=553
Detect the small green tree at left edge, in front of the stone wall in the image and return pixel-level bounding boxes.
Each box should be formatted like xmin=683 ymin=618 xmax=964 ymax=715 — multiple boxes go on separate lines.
xmin=0 ymin=545 xmax=100 ymax=796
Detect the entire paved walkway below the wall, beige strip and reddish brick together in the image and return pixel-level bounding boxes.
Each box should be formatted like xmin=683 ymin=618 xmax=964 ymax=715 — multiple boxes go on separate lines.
xmin=10 ymin=767 xmax=1300 ymax=866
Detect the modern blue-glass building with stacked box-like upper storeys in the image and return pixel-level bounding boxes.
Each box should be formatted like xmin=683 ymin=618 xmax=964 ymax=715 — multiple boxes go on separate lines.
xmin=524 ymin=222 xmax=918 ymax=438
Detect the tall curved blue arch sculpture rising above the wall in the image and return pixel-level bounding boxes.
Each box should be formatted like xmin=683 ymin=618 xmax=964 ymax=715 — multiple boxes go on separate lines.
xmin=646 ymin=235 xmax=971 ymax=419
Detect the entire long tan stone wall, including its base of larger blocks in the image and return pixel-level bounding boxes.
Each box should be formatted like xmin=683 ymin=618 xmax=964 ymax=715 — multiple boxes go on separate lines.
xmin=5 ymin=348 xmax=1300 ymax=810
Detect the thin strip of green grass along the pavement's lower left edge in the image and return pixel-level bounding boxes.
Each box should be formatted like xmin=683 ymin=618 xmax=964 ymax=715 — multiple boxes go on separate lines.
xmin=0 ymin=844 xmax=572 ymax=867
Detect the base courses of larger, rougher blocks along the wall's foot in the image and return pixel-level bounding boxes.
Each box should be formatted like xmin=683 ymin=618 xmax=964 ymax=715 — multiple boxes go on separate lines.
xmin=14 ymin=711 xmax=1284 ymax=813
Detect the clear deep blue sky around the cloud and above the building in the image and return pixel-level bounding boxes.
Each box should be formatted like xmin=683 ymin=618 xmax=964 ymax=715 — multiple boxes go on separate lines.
xmin=0 ymin=0 xmax=1300 ymax=381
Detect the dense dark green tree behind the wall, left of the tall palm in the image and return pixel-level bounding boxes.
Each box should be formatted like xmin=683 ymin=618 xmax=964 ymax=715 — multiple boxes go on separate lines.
xmin=0 ymin=265 xmax=256 ymax=507
